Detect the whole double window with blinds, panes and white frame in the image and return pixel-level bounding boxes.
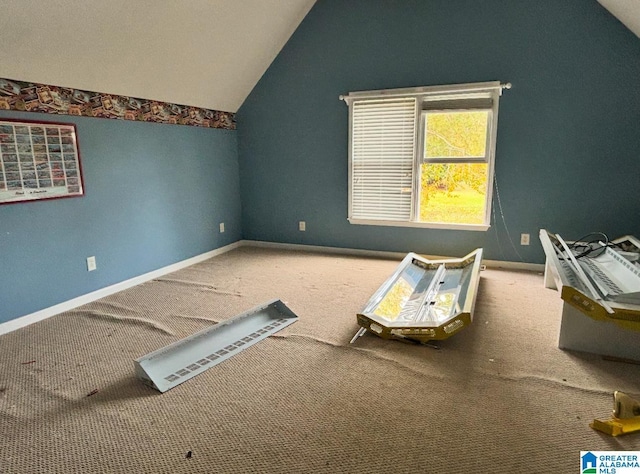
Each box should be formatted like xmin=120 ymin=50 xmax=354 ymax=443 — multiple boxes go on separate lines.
xmin=344 ymin=82 xmax=508 ymax=230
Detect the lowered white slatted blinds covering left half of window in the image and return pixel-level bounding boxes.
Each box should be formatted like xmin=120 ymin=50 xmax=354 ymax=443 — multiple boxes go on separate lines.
xmin=349 ymin=97 xmax=417 ymax=221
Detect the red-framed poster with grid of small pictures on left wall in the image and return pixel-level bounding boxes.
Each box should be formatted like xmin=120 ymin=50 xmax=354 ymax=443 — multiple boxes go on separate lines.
xmin=0 ymin=119 xmax=84 ymax=204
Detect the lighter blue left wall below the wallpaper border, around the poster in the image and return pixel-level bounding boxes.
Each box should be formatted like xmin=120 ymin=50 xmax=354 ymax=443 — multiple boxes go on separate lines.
xmin=0 ymin=111 xmax=242 ymax=323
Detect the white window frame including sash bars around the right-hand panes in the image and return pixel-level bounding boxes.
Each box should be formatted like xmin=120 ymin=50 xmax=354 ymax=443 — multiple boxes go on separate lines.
xmin=341 ymin=81 xmax=504 ymax=231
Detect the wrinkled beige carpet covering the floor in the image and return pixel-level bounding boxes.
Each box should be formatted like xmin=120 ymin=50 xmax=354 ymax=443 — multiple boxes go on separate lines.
xmin=0 ymin=247 xmax=640 ymax=474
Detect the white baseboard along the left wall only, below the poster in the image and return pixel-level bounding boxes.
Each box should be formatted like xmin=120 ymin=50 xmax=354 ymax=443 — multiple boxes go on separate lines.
xmin=0 ymin=241 xmax=242 ymax=335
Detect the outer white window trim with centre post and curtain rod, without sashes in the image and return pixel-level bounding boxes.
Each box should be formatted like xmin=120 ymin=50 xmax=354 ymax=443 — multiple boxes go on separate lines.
xmin=340 ymin=81 xmax=504 ymax=231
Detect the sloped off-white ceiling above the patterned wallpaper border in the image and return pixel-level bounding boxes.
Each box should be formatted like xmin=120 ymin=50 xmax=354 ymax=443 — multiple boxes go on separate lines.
xmin=0 ymin=0 xmax=315 ymax=112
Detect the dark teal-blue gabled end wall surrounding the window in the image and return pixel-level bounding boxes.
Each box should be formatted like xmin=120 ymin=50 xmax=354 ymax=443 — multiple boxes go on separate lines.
xmin=237 ymin=0 xmax=640 ymax=263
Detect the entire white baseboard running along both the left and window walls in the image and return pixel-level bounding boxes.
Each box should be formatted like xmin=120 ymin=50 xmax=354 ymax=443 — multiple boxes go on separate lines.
xmin=0 ymin=240 xmax=544 ymax=335
